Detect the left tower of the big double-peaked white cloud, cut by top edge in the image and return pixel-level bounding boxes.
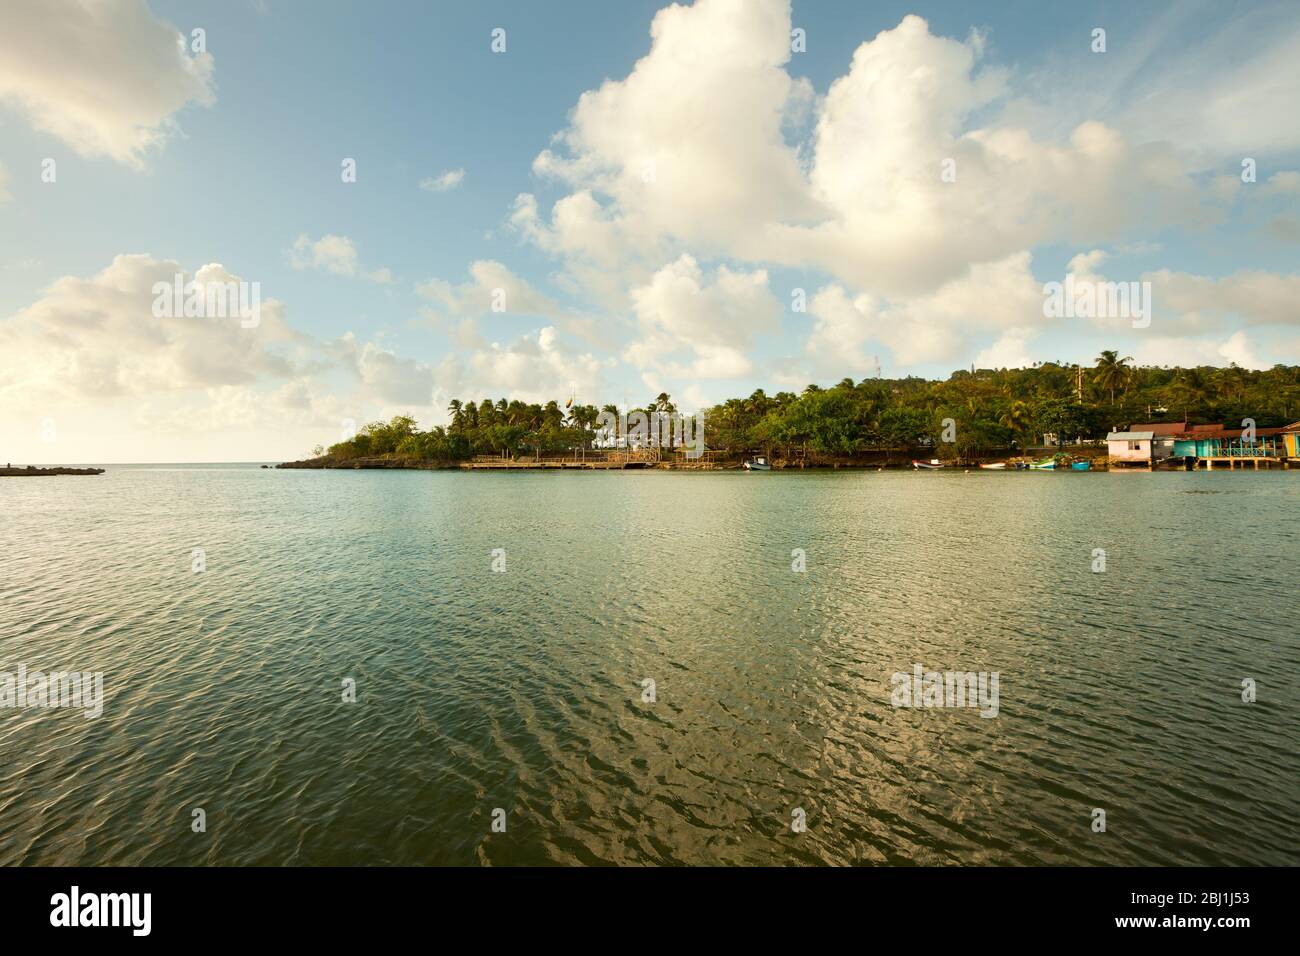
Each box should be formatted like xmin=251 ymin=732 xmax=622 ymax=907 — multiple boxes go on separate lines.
xmin=512 ymin=0 xmax=818 ymax=303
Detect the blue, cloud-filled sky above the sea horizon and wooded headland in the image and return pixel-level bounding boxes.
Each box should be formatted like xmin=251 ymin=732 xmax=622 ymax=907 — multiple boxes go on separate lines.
xmin=0 ymin=0 xmax=1300 ymax=463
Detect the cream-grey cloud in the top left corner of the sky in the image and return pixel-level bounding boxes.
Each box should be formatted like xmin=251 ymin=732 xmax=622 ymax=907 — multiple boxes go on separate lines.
xmin=0 ymin=0 xmax=215 ymax=166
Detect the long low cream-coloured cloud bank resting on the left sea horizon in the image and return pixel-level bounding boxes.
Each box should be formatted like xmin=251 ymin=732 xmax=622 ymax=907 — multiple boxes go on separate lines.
xmin=0 ymin=255 xmax=616 ymax=460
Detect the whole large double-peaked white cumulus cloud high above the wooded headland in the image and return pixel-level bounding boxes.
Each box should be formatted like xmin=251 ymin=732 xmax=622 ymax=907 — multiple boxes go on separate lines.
xmin=511 ymin=0 xmax=1221 ymax=303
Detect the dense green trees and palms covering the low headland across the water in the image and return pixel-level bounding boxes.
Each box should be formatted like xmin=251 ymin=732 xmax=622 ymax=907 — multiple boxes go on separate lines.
xmin=317 ymin=351 xmax=1300 ymax=460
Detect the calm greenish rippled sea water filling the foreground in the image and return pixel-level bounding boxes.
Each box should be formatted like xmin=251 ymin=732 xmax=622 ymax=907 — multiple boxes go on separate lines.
xmin=0 ymin=466 xmax=1300 ymax=865
